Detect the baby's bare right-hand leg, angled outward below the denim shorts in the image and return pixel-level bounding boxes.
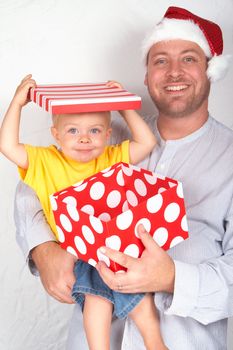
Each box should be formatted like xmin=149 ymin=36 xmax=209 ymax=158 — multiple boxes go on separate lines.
xmin=129 ymin=293 xmax=167 ymax=350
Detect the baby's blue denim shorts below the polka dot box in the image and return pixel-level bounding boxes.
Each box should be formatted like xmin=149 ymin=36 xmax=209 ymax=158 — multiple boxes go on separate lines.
xmin=72 ymin=260 xmax=145 ymax=319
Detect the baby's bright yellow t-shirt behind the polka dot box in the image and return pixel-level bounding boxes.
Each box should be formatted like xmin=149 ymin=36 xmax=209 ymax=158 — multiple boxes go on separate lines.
xmin=19 ymin=140 xmax=129 ymax=239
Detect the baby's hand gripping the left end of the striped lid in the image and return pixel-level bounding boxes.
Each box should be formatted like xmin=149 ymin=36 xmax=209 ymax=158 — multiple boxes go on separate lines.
xmin=12 ymin=74 xmax=36 ymax=107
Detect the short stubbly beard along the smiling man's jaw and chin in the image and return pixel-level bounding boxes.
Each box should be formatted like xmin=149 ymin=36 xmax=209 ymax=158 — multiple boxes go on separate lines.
xmin=148 ymin=80 xmax=210 ymax=118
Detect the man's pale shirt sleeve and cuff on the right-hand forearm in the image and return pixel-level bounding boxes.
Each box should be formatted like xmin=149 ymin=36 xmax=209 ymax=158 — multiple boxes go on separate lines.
xmin=155 ymin=196 xmax=233 ymax=325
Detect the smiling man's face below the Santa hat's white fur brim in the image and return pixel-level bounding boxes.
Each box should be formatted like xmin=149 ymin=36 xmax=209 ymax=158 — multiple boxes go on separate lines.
xmin=145 ymin=40 xmax=210 ymax=118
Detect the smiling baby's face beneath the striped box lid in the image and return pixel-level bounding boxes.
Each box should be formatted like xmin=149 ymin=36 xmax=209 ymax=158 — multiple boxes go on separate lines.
xmin=51 ymin=112 xmax=111 ymax=163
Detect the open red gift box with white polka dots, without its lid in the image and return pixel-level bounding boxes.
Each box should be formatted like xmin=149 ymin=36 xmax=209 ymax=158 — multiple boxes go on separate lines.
xmin=50 ymin=163 xmax=188 ymax=271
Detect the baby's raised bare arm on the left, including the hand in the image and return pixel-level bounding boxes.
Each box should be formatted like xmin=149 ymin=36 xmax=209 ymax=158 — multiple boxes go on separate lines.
xmin=0 ymin=74 xmax=36 ymax=169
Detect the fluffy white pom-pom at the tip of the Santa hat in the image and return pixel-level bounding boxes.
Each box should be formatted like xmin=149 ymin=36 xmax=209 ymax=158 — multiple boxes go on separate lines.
xmin=206 ymin=55 xmax=232 ymax=83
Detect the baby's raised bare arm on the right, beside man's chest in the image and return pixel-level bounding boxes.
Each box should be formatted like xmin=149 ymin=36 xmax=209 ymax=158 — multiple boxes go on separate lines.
xmin=107 ymin=81 xmax=156 ymax=164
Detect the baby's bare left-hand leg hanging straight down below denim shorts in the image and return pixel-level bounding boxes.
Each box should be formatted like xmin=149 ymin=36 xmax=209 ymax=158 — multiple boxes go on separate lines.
xmin=83 ymin=294 xmax=113 ymax=350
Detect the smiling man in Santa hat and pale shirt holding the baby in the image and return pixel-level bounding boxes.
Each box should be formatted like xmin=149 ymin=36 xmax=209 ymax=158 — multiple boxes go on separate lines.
xmin=16 ymin=7 xmax=233 ymax=350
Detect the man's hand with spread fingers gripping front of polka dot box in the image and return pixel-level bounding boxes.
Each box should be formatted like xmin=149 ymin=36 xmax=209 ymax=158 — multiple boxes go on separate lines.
xmin=97 ymin=225 xmax=175 ymax=293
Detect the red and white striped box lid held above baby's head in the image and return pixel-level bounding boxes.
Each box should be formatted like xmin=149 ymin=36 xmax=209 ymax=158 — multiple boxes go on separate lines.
xmin=30 ymin=83 xmax=141 ymax=114
